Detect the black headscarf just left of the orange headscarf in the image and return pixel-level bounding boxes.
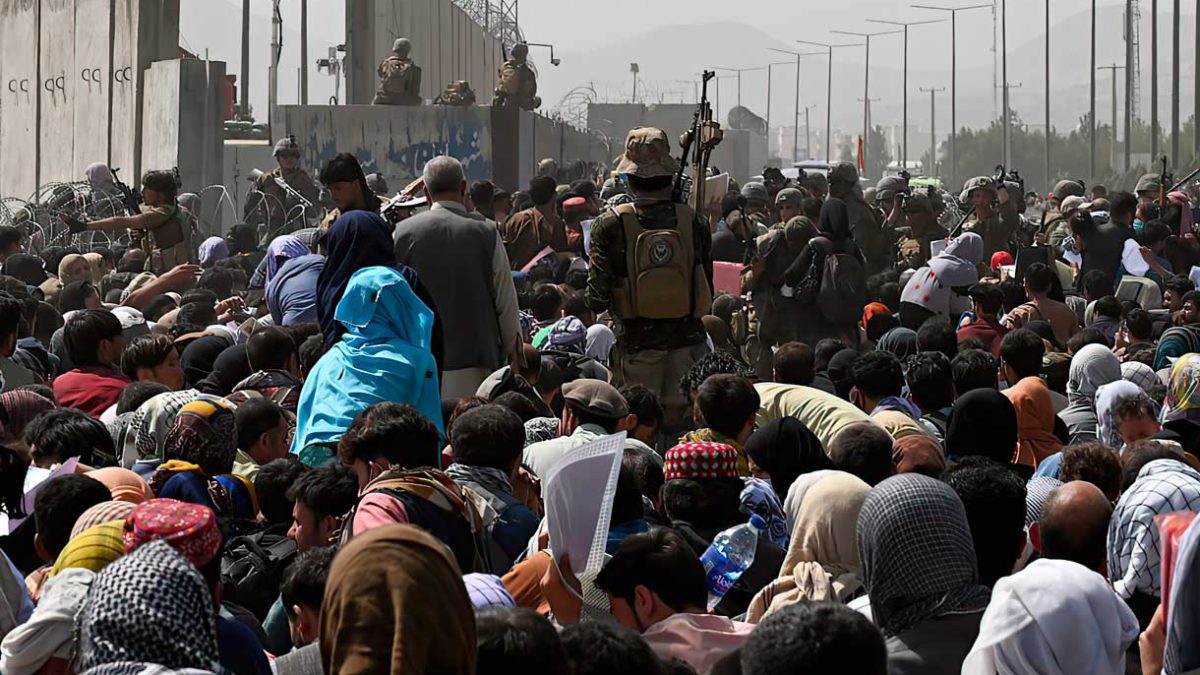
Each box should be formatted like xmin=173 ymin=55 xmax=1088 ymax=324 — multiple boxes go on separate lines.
xmin=946 ymin=389 xmax=1016 ymax=466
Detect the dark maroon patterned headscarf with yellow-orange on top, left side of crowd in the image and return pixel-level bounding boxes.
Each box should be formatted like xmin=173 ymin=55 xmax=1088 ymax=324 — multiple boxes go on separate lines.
xmin=163 ymin=396 xmax=238 ymax=477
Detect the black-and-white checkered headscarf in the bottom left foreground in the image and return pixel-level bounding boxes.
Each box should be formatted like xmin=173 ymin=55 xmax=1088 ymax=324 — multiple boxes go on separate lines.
xmin=79 ymin=542 xmax=218 ymax=675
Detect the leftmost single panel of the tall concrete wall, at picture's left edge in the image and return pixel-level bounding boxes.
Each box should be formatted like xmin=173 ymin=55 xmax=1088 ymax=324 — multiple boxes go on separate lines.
xmin=0 ymin=0 xmax=41 ymax=198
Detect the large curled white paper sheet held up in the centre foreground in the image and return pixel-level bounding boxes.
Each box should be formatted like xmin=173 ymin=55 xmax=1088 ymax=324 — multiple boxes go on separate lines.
xmin=542 ymin=432 xmax=625 ymax=578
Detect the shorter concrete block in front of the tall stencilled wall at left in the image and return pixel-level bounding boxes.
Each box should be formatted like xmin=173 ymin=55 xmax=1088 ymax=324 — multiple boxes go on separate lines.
xmin=142 ymin=59 xmax=226 ymax=192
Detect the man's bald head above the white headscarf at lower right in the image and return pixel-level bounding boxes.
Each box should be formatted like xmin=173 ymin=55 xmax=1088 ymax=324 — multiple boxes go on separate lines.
xmin=1038 ymin=480 xmax=1112 ymax=573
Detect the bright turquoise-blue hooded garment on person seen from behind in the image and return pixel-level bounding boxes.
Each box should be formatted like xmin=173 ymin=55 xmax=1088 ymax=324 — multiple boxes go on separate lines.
xmin=292 ymin=267 xmax=443 ymax=456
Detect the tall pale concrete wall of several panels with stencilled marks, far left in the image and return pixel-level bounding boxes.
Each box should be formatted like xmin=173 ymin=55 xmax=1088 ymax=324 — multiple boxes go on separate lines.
xmin=0 ymin=0 xmax=179 ymax=198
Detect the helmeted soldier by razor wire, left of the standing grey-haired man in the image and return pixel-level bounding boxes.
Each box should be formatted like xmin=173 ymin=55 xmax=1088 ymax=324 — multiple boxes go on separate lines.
xmin=242 ymin=136 xmax=320 ymax=231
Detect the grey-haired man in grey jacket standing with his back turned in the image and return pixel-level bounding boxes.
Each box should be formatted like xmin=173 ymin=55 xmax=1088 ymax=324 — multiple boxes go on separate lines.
xmin=395 ymin=156 xmax=521 ymax=399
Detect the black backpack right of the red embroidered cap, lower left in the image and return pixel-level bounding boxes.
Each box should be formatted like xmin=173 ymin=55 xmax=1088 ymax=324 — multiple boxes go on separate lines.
xmin=221 ymin=531 xmax=296 ymax=621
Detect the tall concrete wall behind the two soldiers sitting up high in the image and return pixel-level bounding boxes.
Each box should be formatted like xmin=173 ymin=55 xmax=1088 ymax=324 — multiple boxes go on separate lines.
xmin=346 ymin=0 xmax=504 ymax=104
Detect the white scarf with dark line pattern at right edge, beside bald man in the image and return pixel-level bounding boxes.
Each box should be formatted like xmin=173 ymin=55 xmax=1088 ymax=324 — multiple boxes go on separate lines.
xmin=1108 ymin=459 xmax=1200 ymax=599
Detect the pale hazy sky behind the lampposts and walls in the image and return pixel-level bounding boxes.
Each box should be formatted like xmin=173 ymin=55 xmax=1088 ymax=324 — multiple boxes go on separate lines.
xmin=182 ymin=0 xmax=1195 ymax=136
